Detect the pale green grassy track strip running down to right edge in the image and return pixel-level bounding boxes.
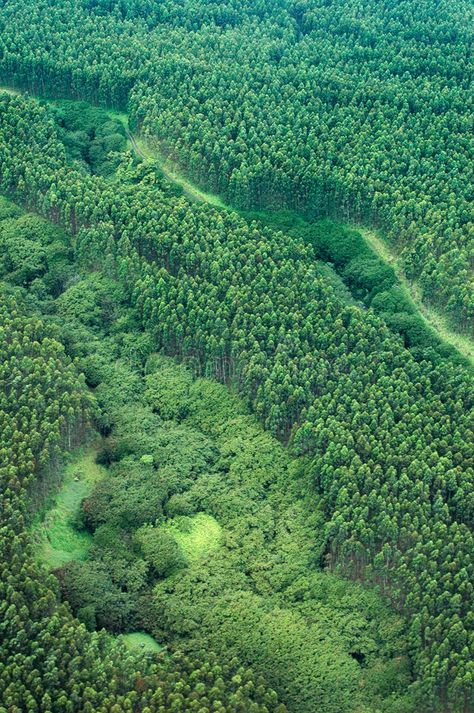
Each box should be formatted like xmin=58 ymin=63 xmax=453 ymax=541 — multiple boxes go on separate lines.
xmin=360 ymin=225 xmax=474 ymax=366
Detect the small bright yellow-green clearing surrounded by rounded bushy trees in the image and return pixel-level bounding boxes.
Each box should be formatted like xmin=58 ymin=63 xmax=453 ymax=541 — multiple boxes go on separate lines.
xmin=165 ymin=512 xmax=222 ymax=563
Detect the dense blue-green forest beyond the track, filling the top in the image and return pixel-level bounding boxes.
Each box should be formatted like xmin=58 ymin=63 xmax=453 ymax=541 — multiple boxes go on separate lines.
xmin=0 ymin=0 xmax=474 ymax=329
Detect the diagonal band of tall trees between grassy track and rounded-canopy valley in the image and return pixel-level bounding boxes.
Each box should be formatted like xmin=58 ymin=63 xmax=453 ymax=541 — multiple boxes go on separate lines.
xmin=0 ymin=89 xmax=472 ymax=705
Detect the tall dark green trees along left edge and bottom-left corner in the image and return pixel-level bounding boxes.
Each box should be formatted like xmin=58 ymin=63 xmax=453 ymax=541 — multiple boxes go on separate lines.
xmin=0 ymin=200 xmax=286 ymax=713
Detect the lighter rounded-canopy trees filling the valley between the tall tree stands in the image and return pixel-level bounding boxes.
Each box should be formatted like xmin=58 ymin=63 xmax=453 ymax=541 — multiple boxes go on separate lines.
xmin=0 ymin=193 xmax=412 ymax=710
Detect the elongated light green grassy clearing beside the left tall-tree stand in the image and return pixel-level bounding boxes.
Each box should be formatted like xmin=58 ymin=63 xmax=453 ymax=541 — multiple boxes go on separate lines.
xmin=32 ymin=447 xmax=106 ymax=569
